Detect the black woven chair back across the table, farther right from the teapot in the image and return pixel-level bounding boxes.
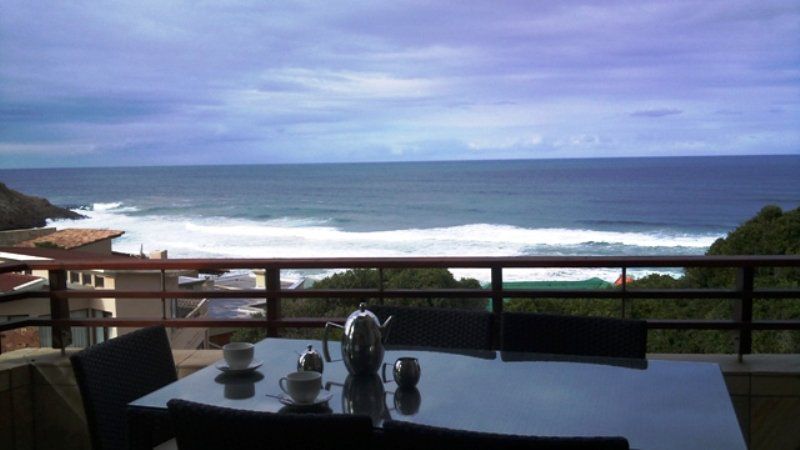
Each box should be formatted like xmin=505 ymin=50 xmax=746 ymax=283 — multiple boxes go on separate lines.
xmin=501 ymin=313 xmax=647 ymax=359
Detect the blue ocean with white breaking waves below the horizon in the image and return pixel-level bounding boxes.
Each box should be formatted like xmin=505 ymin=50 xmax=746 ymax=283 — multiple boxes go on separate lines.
xmin=0 ymin=156 xmax=800 ymax=281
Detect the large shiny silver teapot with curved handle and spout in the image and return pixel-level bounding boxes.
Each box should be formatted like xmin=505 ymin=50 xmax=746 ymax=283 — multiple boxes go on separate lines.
xmin=322 ymin=303 xmax=392 ymax=375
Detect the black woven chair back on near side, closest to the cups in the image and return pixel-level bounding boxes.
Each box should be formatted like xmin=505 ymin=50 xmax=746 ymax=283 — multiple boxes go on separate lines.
xmin=167 ymin=399 xmax=373 ymax=450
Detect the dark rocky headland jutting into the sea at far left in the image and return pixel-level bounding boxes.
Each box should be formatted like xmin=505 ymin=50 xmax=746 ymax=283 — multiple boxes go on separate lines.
xmin=0 ymin=183 xmax=86 ymax=231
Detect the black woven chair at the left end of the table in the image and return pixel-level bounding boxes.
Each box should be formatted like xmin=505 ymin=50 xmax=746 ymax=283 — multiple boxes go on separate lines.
xmin=70 ymin=326 xmax=177 ymax=450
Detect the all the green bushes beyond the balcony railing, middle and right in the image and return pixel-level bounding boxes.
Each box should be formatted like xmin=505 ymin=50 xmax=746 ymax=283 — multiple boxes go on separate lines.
xmin=234 ymin=206 xmax=800 ymax=353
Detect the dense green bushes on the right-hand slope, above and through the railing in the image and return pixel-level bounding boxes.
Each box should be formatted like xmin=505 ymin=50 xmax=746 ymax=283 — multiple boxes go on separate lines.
xmin=506 ymin=206 xmax=800 ymax=353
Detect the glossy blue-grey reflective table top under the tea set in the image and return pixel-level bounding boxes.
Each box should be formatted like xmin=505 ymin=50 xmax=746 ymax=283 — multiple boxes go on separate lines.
xmin=131 ymin=338 xmax=746 ymax=449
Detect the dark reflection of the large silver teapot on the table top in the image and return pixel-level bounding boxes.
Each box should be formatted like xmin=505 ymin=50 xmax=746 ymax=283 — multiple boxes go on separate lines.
xmin=326 ymin=374 xmax=391 ymax=427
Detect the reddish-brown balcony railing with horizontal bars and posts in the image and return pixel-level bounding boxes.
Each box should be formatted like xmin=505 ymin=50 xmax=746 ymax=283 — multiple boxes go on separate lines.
xmin=0 ymin=255 xmax=800 ymax=358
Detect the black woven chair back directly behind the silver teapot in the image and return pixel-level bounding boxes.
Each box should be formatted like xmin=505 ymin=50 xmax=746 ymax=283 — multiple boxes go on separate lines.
xmin=367 ymin=305 xmax=492 ymax=350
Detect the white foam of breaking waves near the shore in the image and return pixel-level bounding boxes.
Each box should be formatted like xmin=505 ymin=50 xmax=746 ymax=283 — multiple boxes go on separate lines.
xmin=53 ymin=202 xmax=718 ymax=281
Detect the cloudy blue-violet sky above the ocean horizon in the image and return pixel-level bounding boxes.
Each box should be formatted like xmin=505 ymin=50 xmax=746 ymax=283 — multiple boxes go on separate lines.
xmin=0 ymin=0 xmax=800 ymax=168
